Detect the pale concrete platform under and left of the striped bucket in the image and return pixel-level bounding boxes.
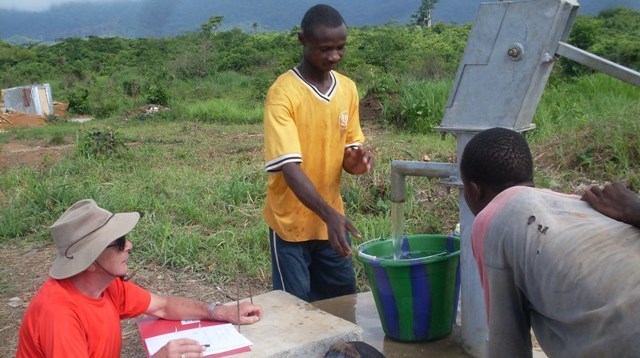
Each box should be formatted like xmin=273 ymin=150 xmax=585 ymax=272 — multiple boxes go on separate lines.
xmin=232 ymin=291 xmax=546 ymax=358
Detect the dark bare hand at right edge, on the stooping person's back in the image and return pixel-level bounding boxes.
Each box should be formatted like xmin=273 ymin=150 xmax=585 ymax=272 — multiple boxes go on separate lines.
xmin=582 ymin=183 xmax=640 ymax=228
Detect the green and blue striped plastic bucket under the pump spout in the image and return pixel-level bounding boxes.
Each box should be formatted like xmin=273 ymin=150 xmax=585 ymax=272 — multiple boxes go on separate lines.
xmin=357 ymin=235 xmax=460 ymax=342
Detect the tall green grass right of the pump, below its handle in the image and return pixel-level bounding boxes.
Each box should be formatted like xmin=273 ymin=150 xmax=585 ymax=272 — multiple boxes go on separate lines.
xmin=531 ymin=74 xmax=640 ymax=190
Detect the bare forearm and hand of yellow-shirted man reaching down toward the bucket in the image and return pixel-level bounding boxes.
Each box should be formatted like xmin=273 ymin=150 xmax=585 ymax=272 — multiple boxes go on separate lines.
xmin=282 ymin=163 xmax=360 ymax=257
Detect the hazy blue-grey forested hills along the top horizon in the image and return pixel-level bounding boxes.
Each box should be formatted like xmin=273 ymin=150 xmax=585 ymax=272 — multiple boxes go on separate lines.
xmin=0 ymin=0 xmax=640 ymax=43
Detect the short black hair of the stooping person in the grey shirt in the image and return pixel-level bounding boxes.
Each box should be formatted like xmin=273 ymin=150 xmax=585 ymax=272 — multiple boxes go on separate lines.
xmin=460 ymin=128 xmax=533 ymax=192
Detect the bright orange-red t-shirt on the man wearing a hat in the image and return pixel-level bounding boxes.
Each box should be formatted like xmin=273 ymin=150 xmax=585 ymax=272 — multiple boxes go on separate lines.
xmin=16 ymin=278 xmax=151 ymax=358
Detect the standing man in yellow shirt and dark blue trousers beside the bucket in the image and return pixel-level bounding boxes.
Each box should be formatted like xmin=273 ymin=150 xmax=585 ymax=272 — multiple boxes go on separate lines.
xmin=263 ymin=5 xmax=373 ymax=301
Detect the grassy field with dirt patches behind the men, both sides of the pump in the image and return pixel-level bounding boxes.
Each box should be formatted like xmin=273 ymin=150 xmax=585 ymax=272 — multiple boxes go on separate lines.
xmin=0 ymin=71 xmax=640 ymax=357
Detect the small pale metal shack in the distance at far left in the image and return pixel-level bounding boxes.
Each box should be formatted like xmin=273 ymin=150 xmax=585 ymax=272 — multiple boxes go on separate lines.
xmin=2 ymin=83 xmax=53 ymax=116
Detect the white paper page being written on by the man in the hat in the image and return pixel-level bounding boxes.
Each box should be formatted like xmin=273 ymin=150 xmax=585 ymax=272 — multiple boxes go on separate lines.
xmin=145 ymin=323 xmax=253 ymax=356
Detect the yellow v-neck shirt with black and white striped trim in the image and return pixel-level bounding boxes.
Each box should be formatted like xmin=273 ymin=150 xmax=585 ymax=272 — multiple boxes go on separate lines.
xmin=263 ymin=69 xmax=364 ymax=242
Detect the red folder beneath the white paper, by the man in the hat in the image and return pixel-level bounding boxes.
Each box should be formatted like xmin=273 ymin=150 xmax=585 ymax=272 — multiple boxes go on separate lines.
xmin=136 ymin=317 xmax=251 ymax=358
